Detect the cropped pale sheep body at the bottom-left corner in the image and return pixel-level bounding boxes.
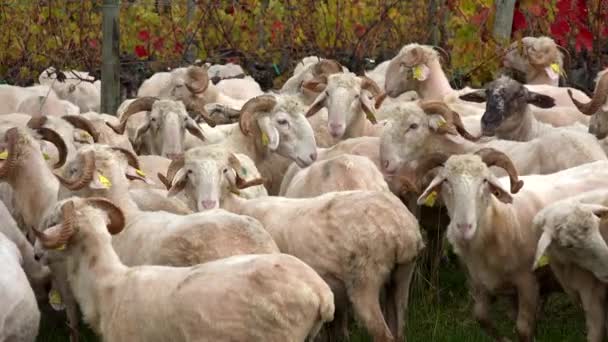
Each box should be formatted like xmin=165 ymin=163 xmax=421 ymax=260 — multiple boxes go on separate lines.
xmin=0 ymin=232 xmax=40 ymax=342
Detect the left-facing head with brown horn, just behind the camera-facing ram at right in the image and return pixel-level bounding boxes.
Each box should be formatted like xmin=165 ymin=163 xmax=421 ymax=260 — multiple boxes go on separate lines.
xmin=380 ymin=101 xmax=476 ymax=176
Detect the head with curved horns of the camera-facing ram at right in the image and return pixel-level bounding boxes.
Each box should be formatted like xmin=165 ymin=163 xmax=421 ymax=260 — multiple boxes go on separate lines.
xmin=417 ymin=149 xmax=523 ymax=241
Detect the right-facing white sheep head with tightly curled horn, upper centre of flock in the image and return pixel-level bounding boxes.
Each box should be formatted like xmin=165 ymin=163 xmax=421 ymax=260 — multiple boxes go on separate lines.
xmin=239 ymin=95 xmax=317 ymax=167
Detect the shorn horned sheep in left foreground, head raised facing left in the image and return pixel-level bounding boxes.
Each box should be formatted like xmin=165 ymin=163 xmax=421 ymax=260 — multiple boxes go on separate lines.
xmin=37 ymin=198 xmax=334 ymax=342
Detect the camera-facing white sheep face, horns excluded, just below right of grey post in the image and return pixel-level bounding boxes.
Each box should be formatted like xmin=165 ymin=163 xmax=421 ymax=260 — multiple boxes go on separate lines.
xmin=134 ymin=100 xmax=203 ymax=159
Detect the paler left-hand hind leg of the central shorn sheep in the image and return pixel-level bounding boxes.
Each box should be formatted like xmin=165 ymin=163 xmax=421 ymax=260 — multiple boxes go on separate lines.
xmin=348 ymin=280 xmax=394 ymax=342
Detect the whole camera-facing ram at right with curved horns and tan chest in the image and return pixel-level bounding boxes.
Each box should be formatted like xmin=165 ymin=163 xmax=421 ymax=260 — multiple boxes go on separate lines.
xmin=418 ymin=149 xmax=608 ymax=341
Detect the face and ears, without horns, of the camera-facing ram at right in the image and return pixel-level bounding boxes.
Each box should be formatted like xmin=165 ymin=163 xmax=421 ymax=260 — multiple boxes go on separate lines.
xmin=418 ymin=155 xmax=512 ymax=244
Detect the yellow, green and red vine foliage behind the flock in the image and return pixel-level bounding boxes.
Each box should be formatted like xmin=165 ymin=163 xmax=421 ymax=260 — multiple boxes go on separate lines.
xmin=0 ymin=0 xmax=608 ymax=94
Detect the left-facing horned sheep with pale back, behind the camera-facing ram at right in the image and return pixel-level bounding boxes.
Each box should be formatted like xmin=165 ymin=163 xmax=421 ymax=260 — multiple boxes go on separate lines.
xmin=380 ymin=101 xmax=606 ymax=176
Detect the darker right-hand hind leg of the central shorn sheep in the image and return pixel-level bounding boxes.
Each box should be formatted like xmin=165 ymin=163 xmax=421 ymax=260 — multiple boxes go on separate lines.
xmin=386 ymin=262 xmax=416 ymax=341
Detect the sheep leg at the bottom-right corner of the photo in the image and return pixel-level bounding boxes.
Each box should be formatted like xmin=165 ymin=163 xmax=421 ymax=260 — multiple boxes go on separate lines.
xmin=579 ymin=282 xmax=606 ymax=342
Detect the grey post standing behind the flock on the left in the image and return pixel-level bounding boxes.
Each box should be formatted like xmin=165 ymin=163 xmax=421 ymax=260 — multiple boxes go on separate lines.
xmin=101 ymin=0 xmax=120 ymax=115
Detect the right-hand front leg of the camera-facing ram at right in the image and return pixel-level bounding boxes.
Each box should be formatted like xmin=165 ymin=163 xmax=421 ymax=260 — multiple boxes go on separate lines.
xmin=515 ymin=273 xmax=540 ymax=341
